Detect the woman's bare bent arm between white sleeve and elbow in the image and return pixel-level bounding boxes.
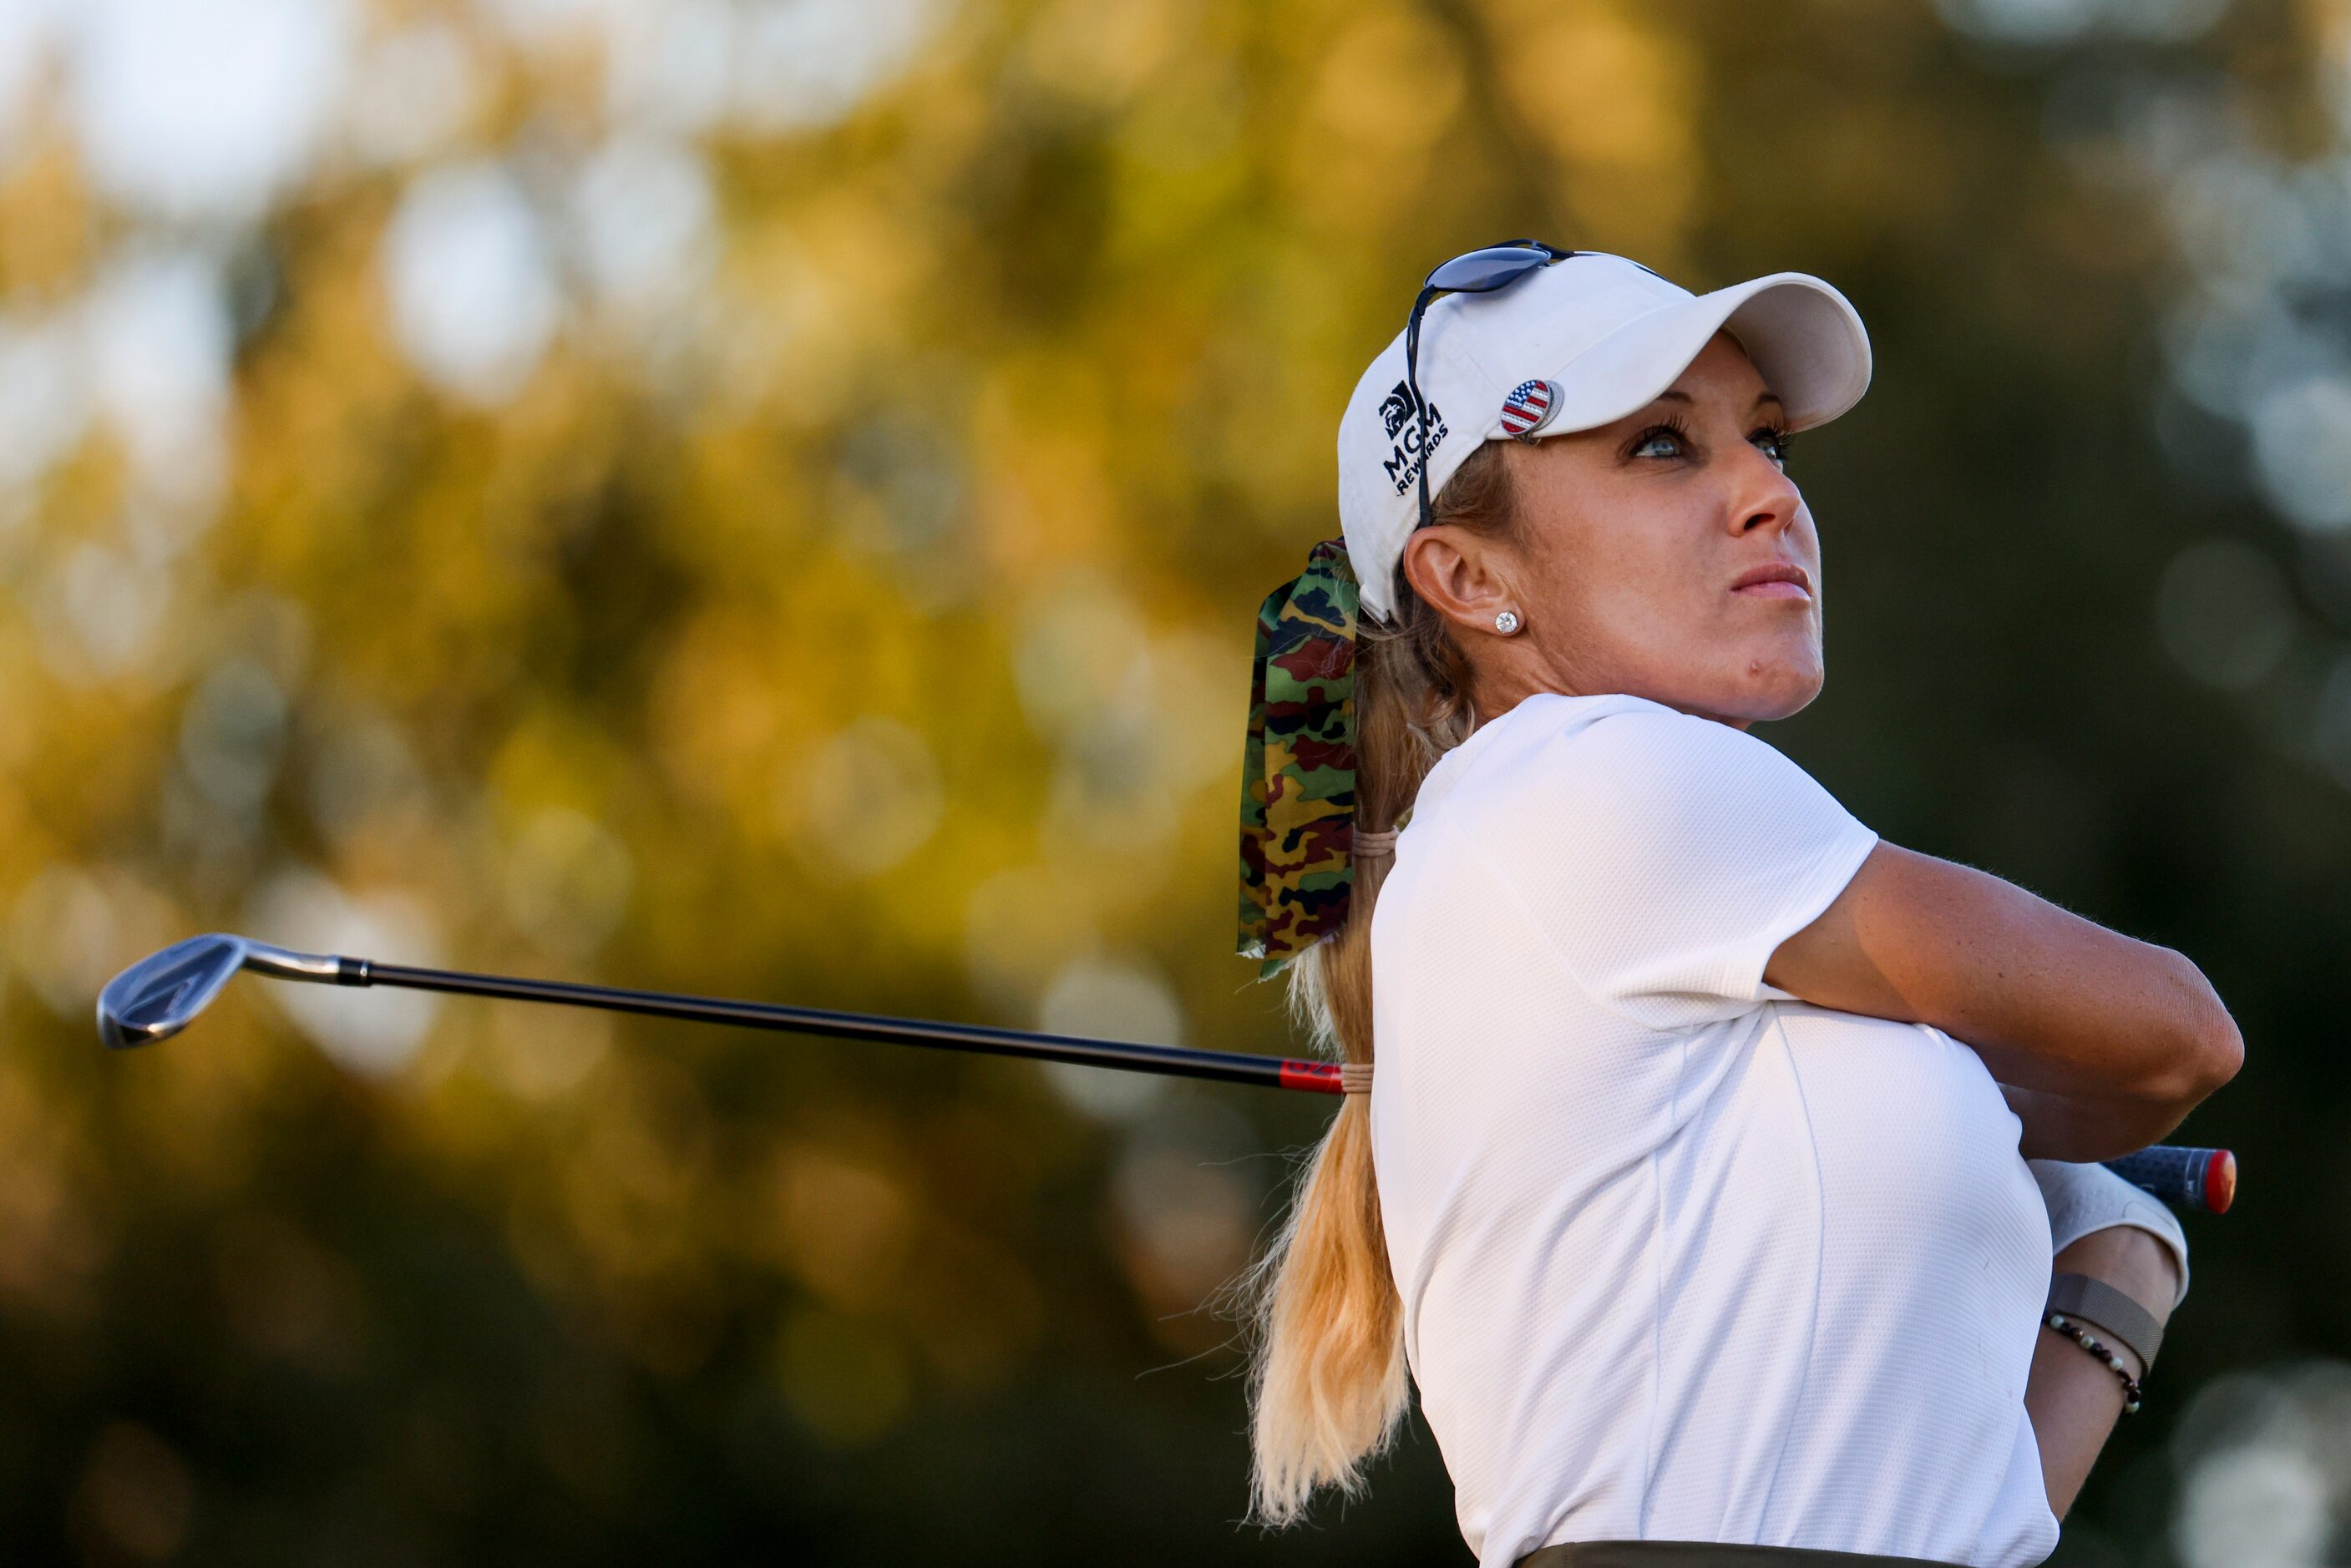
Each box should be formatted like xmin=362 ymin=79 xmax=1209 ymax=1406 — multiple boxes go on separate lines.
xmin=1763 ymin=844 xmax=2245 ymax=1159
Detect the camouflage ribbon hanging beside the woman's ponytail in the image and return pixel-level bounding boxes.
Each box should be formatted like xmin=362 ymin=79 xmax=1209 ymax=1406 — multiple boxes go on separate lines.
xmin=1239 ymin=539 xmax=1356 ymax=978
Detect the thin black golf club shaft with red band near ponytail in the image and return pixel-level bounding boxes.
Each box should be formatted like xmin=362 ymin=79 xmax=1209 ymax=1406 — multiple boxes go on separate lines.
xmin=334 ymin=957 xmax=1340 ymax=1093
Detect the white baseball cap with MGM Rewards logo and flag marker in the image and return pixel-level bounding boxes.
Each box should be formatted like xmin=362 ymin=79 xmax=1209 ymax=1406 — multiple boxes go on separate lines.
xmin=1338 ymin=251 xmax=1869 ymax=620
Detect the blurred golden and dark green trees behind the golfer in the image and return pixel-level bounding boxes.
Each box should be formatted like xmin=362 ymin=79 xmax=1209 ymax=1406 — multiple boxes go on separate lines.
xmin=0 ymin=0 xmax=2351 ymax=1568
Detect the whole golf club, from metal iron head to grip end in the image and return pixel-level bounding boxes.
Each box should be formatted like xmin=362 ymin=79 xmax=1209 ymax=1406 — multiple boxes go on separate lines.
xmin=99 ymin=931 xmax=2236 ymax=1213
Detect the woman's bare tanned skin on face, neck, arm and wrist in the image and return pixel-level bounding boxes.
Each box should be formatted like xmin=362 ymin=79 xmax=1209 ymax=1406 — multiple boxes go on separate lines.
xmin=1404 ymin=334 xmax=2245 ymax=1516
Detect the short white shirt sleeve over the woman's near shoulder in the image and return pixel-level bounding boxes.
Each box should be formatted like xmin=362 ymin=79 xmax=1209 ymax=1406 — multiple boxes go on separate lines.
xmin=1462 ymin=703 xmax=1878 ymax=1027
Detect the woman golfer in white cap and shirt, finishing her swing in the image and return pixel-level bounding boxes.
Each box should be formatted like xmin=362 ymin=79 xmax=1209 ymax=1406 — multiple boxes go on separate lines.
xmin=1241 ymin=242 xmax=2243 ymax=1568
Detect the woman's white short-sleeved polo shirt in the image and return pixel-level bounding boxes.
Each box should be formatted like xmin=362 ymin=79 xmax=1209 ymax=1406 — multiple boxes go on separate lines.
xmin=1371 ymin=695 xmax=2057 ymax=1568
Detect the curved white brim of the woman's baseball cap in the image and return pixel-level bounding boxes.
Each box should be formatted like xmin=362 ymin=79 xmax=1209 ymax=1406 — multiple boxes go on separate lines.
xmin=1543 ymin=273 xmax=1869 ymax=435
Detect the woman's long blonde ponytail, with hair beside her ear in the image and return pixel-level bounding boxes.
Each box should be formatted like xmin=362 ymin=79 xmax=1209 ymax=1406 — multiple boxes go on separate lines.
xmin=1241 ymin=442 xmax=1512 ymax=1525
